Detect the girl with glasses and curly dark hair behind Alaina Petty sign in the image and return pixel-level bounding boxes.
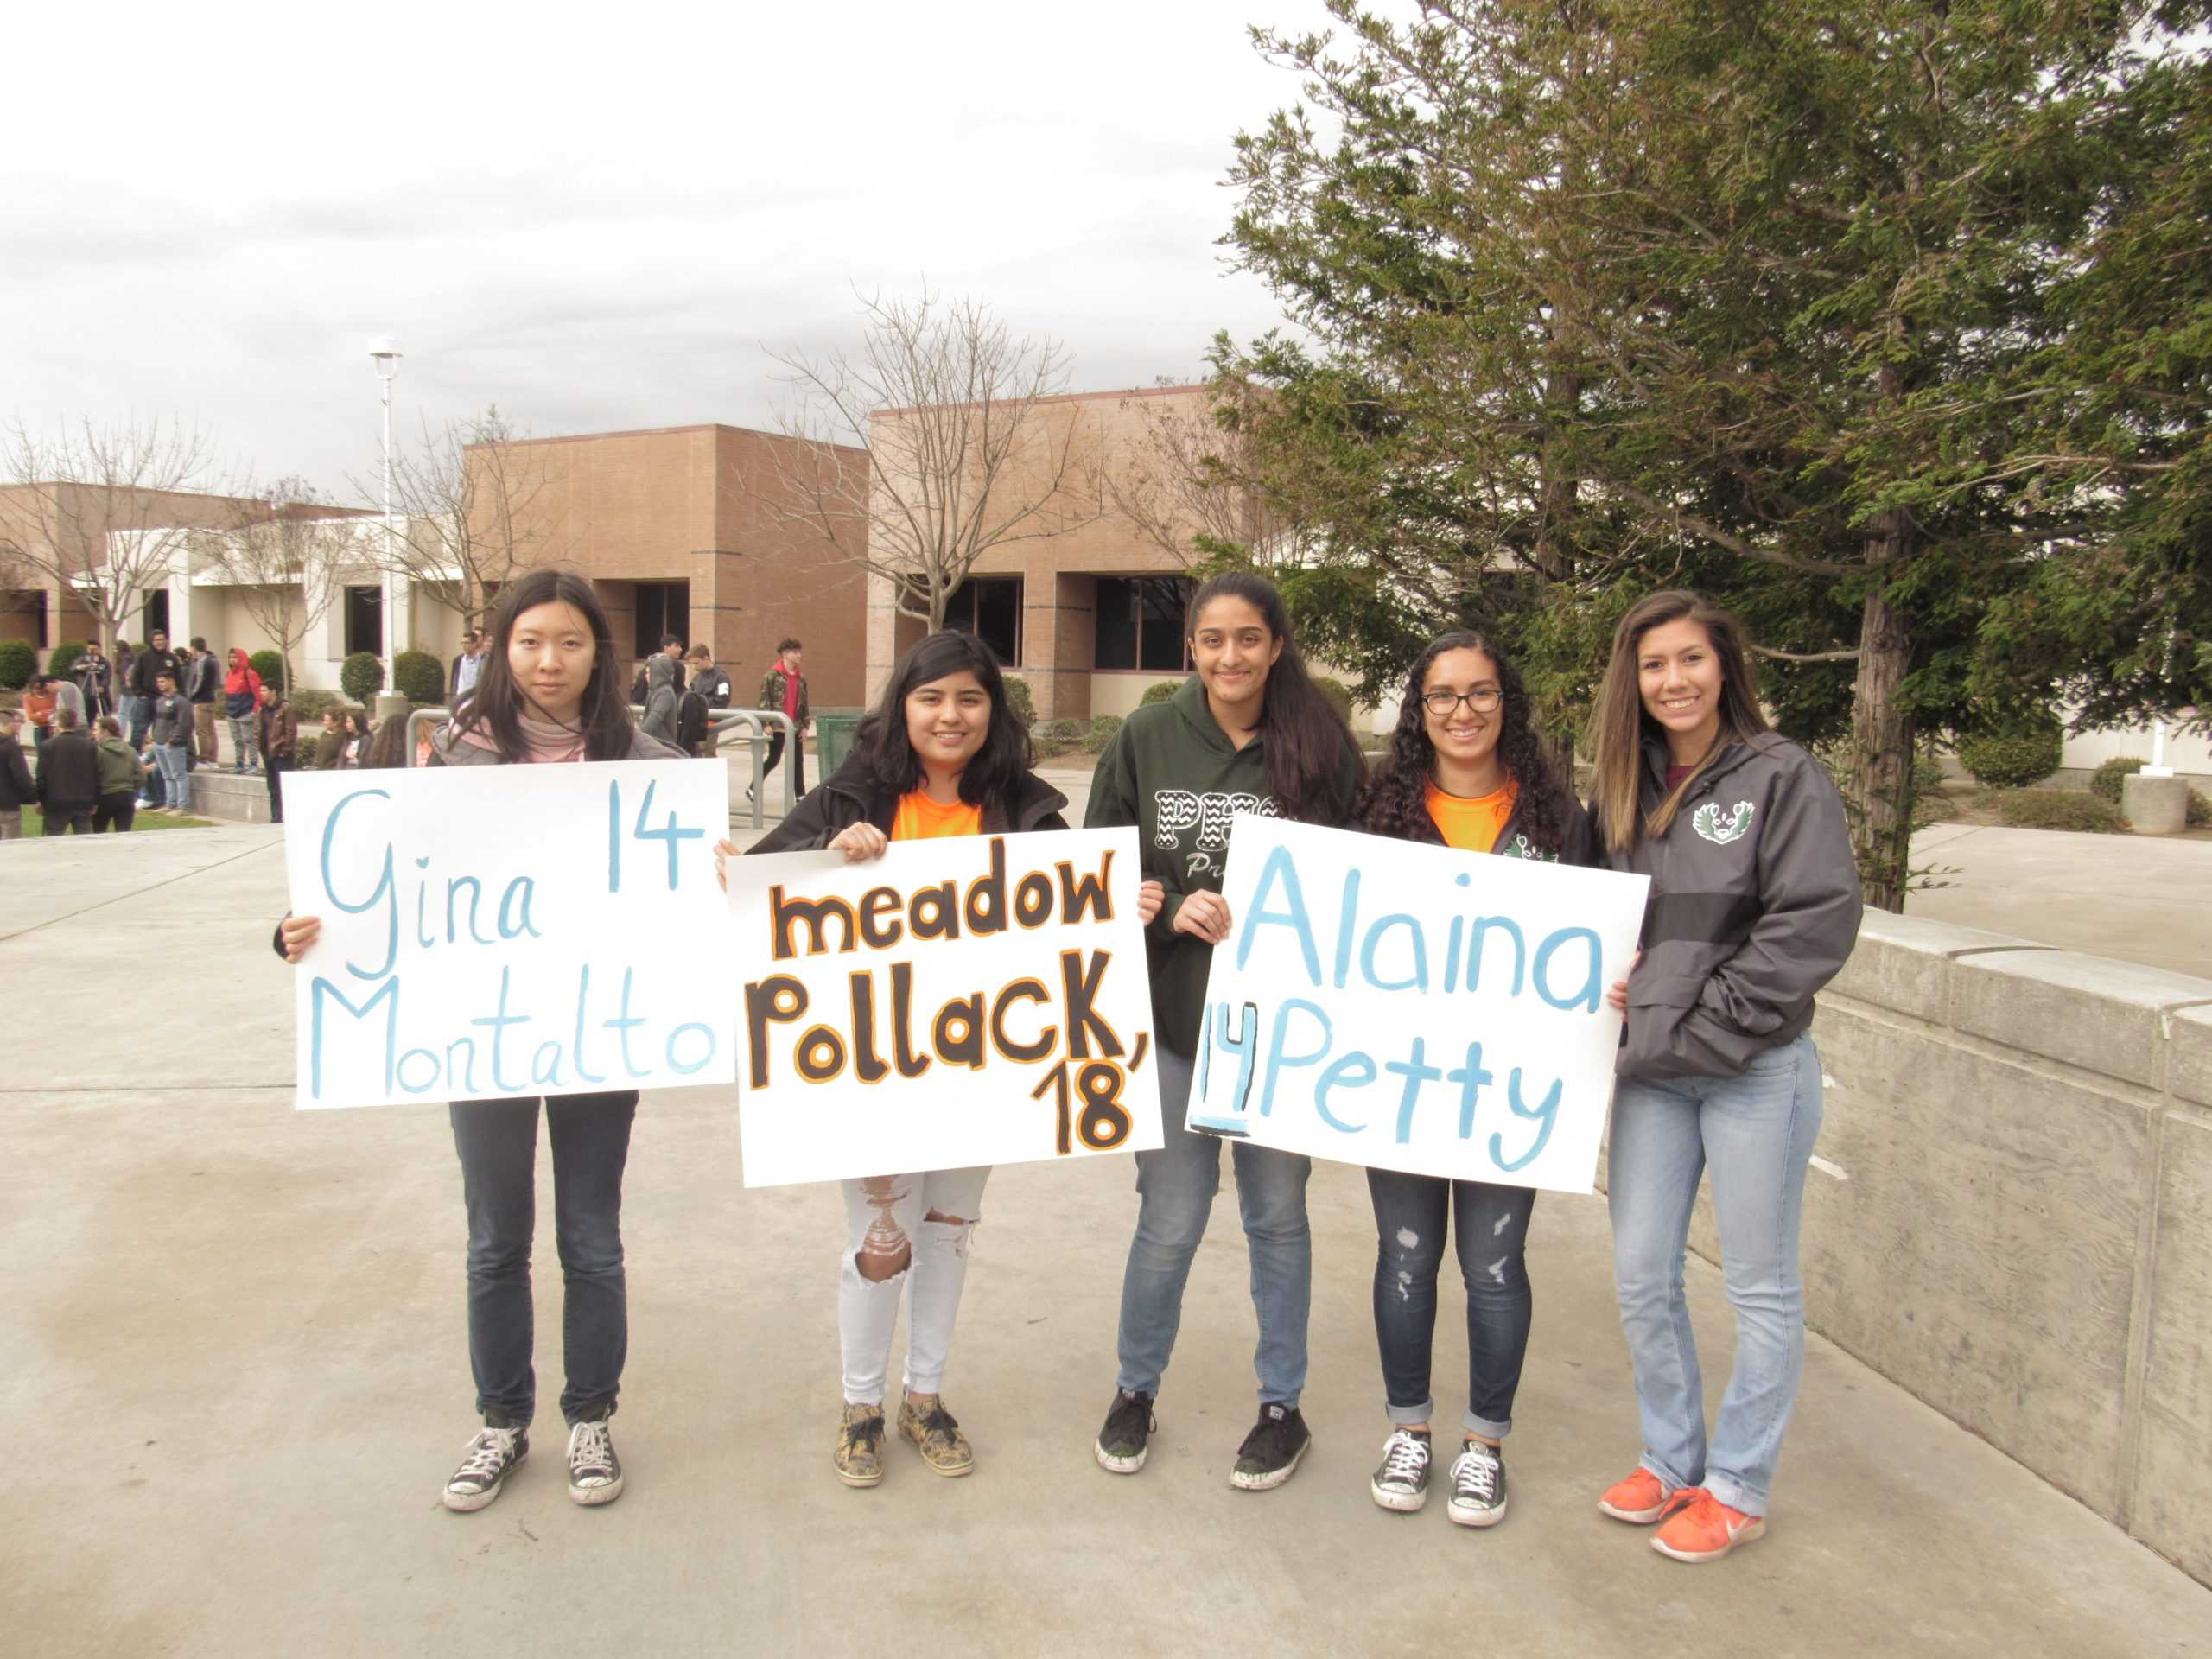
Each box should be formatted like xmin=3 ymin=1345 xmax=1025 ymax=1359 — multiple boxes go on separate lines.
xmin=1354 ymin=632 xmax=1599 ymax=1526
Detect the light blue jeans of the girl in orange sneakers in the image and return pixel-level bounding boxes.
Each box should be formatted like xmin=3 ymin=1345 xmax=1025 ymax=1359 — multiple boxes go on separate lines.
xmin=1608 ymin=1035 xmax=1821 ymax=1516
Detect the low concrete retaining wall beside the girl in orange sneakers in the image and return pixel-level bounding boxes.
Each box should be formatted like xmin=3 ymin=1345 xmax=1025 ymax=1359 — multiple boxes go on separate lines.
xmin=1692 ymin=912 xmax=2212 ymax=1584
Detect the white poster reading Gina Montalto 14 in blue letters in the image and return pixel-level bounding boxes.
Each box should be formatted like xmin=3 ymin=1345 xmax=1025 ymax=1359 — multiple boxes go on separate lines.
xmin=283 ymin=761 xmax=736 ymax=1106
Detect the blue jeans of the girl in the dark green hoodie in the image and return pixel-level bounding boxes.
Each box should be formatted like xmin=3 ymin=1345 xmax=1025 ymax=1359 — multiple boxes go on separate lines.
xmin=1117 ymin=1046 xmax=1314 ymax=1407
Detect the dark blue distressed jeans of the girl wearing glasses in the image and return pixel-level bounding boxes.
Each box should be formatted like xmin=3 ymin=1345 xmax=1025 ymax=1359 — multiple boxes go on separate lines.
xmin=1367 ymin=1170 xmax=1535 ymax=1440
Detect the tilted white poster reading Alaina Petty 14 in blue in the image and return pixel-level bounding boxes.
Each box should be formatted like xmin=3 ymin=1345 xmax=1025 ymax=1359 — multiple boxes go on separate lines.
xmin=1190 ymin=814 xmax=1648 ymax=1192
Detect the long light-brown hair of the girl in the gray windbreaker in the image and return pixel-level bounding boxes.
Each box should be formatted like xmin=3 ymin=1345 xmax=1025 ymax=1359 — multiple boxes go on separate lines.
xmin=1595 ymin=588 xmax=1772 ymax=852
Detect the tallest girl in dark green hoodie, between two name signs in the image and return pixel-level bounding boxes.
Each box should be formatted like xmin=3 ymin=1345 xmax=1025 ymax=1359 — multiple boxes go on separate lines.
xmin=1084 ymin=570 xmax=1360 ymax=1491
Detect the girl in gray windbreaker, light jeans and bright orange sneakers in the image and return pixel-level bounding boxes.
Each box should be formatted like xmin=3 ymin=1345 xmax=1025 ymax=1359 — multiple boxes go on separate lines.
xmin=1597 ymin=593 xmax=1860 ymax=1561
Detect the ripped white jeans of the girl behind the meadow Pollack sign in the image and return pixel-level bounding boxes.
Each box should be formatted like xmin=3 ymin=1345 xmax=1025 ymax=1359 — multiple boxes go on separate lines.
xmin=836 ymin=1166 xmax=991 ymax=1405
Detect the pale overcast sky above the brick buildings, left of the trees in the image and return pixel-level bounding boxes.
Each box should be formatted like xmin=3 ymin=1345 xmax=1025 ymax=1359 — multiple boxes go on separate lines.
xmin=0 ymin=0 xmax=1325 ymax=506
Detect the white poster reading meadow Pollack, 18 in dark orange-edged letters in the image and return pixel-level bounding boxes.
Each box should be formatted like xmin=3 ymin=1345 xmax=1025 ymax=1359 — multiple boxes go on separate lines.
xmin=730 ymin=830 xmax=1159 ymax=1185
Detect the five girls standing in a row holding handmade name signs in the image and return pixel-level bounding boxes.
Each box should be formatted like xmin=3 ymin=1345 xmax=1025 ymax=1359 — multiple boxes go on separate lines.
xmin=279 ymin=573 xmax=1858 ymax=1561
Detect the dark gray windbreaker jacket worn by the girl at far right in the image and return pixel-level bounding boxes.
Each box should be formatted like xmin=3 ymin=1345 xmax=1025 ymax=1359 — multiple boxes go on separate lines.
xmin=1606 ymin=732 xmax=1860 ymax=1077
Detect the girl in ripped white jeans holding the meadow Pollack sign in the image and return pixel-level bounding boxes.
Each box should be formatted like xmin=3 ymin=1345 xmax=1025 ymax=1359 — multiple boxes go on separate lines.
xmin=719 ymin=632 xmax=1157 ymax=1486
